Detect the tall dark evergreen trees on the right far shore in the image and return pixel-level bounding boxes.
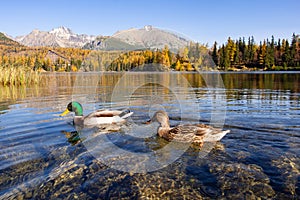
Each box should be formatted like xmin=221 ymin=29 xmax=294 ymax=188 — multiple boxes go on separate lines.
xmin=210 ymin=34 xmax=300 ymax=70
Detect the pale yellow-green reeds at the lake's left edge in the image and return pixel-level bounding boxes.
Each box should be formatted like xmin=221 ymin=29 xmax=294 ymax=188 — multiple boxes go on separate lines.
xmin=0 ymin=66 xmax=40 ymax=86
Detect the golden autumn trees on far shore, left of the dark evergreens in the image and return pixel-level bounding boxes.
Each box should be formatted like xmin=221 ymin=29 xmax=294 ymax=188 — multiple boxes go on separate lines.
xmin=0 ymin=43 xmax=209 ymax=72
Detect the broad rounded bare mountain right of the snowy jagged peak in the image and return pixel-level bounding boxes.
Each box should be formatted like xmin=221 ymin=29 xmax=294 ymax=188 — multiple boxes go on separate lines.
xmin=84 ymin=25 xmax=189 ymax=52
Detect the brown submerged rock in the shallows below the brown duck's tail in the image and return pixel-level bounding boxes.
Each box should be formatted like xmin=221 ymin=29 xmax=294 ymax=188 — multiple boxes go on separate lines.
xmin=209 ymin=163 xmax=275 ymax=199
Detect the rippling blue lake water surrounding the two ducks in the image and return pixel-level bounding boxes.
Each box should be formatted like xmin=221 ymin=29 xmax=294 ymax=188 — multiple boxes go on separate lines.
xmin=0 ymin=72 xmax=300 ymax=199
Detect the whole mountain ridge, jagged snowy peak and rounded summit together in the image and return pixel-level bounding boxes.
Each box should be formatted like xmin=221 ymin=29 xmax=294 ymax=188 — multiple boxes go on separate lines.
xmin=14 ymin=25 xmax=189 ymax=51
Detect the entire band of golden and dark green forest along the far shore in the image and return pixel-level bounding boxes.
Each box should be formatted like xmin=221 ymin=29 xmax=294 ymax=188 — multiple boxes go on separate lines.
xmin=0 ymin=34 xmax=300 ymax=72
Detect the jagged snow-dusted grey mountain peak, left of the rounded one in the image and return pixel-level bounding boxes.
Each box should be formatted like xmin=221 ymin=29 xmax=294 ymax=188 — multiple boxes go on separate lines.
xmin=15 ymin=26 xmax=96 ymax=48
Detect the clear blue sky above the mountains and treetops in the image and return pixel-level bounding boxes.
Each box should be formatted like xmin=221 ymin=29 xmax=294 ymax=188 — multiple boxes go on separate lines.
xmin=0 ymin=0 xmax=300 ymax=46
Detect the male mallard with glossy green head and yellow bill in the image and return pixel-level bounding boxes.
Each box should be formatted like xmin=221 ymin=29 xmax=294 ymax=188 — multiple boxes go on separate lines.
xmin=60 ymin=101 xmax=133 ymax=126
